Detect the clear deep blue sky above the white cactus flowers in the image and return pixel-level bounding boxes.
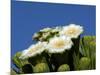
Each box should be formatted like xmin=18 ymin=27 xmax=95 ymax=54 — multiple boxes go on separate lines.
xmin=11 ymin=1 xmax=96 ymax=55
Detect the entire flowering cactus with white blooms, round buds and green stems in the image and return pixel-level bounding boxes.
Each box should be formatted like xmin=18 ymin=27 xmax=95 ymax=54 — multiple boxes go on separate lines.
xmin=11 ymin=24 xmax=96 ymax=75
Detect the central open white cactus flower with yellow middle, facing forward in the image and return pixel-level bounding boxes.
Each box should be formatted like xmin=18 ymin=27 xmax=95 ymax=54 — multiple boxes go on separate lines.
xmin=47 ymin=36 xmax=73 ymax=53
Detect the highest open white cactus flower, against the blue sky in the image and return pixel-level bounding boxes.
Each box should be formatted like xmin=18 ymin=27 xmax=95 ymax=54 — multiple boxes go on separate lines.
xmin=60 ymin=24 xmax=83 ymax=38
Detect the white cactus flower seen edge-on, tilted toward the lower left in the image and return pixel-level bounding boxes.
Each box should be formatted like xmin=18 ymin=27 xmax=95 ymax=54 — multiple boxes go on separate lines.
xmin=20 ymin=42 xmax=47 ymax=59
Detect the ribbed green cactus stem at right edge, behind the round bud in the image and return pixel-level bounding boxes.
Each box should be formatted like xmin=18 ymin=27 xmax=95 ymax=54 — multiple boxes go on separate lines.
xmin=80 ymin=36 xmax=96 ymax=69
